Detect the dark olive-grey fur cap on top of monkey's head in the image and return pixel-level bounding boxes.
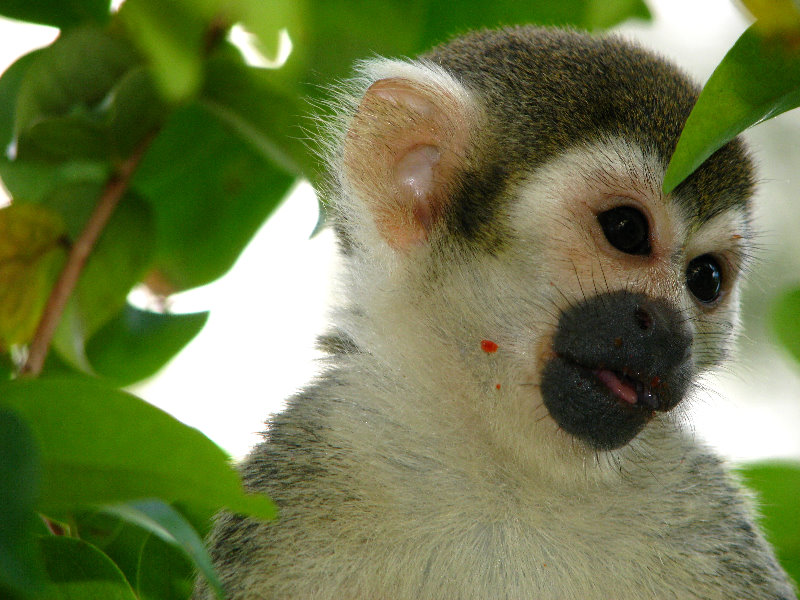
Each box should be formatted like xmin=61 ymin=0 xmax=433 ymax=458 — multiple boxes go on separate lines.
xmin=423 ymin=27 xmax=754 ymax=239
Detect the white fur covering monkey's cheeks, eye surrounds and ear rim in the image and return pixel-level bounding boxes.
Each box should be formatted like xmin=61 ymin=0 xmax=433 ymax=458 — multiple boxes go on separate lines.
xmin=336 ymin=61 xmax=748 ymax=477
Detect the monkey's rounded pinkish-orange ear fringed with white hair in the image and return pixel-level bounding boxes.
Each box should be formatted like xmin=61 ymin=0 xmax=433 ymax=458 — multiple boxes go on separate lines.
xmin=343 ymin=65 xmax=475 ymax=250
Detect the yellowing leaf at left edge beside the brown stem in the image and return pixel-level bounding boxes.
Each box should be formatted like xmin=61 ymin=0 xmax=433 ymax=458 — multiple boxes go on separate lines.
xmin=0 ymin=204 xmax=66 ymax=349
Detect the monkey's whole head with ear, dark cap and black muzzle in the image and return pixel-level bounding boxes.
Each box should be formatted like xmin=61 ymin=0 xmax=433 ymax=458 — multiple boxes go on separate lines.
xmin=330 ymin=28 xmax=754 ymax=458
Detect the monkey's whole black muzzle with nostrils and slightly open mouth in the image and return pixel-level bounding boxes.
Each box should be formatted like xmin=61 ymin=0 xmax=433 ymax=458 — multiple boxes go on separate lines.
xmin=541 ymin=292 xmax=692 ymax=450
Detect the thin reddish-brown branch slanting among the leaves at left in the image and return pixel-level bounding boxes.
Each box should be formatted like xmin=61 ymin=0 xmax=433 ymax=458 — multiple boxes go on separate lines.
xmin=20 ymin=134 xmax=155 ymax=377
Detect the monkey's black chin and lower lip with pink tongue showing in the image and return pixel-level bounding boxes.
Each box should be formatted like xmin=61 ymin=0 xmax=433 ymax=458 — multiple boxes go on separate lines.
xmin=541 ymin=356 xmax=658 ymax=450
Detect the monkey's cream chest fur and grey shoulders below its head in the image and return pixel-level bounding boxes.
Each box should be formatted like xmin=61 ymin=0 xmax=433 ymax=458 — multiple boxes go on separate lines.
xmin=203 ymin=374 xmax=790 ymax=599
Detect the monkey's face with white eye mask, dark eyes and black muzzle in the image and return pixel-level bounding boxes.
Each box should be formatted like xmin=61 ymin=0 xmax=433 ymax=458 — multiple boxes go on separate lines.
xmin=510 ymin=141 xmax=748 ymax=449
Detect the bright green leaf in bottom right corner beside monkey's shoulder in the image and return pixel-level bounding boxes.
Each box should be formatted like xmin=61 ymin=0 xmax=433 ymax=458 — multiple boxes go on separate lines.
xmin=739 ymin=463 xmax=800 ymax=582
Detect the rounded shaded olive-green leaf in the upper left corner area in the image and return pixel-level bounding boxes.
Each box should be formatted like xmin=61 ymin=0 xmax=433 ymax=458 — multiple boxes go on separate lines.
xmin=16 ymin=27 xmax=138 ymax=136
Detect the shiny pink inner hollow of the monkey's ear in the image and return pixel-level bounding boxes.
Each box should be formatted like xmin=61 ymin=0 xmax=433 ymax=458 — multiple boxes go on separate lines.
xmin=394 ymin=144 xmax=440 ymax=237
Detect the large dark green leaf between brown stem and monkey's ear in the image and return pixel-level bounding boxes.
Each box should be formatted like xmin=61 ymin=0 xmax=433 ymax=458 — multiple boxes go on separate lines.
xmin=133 ymin=105 xmax=294 ymax=291
